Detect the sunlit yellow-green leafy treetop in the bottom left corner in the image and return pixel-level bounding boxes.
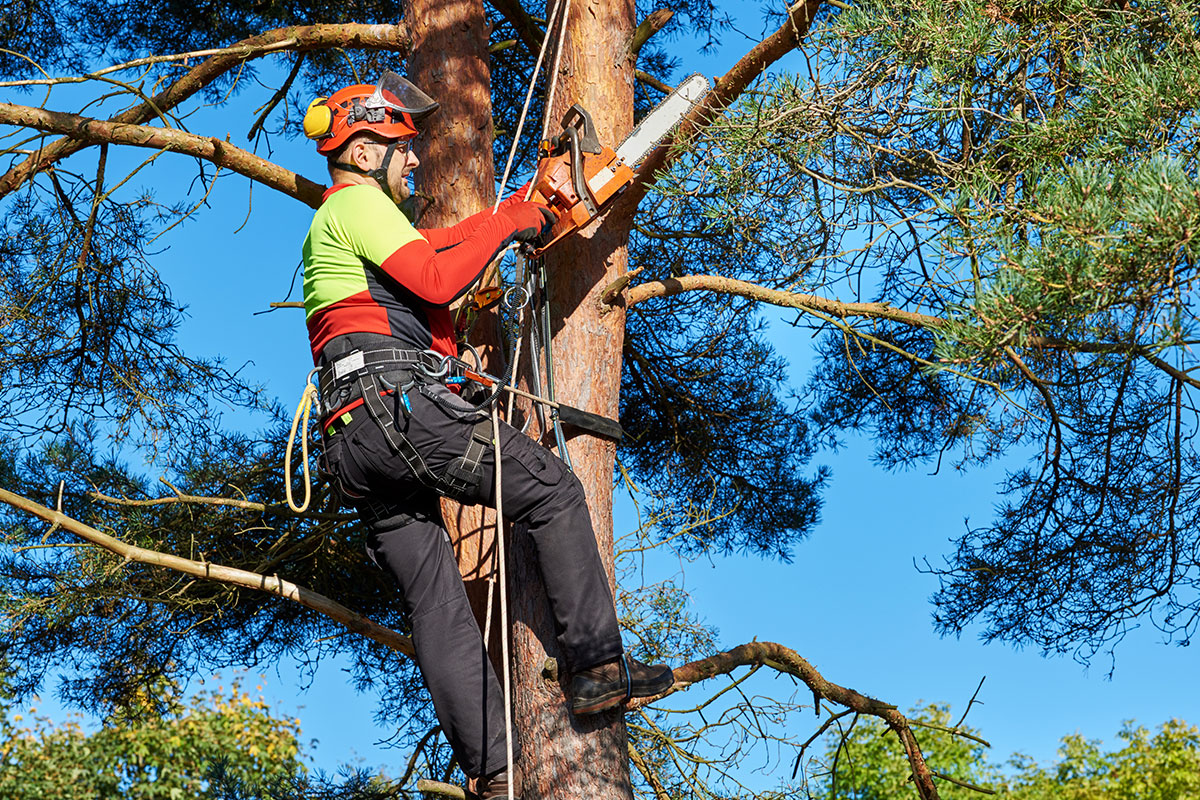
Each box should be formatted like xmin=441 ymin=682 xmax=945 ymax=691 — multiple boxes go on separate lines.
xmin=0 ymin=682 xmax=302 ymax=800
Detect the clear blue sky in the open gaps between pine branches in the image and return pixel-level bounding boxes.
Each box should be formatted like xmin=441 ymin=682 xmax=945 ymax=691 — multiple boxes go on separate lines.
xmin=11 ymin=0 xmax=1200 ymax=786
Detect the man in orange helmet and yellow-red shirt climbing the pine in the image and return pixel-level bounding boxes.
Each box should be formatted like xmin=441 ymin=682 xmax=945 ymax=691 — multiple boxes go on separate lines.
xmin=304 ymin=72 xmax=673 ymax=799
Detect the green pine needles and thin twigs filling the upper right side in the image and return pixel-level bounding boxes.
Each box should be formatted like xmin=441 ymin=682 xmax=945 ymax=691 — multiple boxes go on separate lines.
xmin=648 ymin=0 xmax=1200 ymax=661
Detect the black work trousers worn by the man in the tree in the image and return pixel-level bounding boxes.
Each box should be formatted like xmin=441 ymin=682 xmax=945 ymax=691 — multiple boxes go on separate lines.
xmin=325 ymin=384 xmax=622 ymax=777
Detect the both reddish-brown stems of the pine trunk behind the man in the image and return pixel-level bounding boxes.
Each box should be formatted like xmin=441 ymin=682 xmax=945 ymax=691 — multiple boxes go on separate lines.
xmin=408 ymin=0 xmax=635 ymax=800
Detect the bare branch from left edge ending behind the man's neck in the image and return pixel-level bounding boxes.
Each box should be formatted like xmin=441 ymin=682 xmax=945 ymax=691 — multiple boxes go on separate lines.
xmin=0 ymin=102 xmax=325 ymax=209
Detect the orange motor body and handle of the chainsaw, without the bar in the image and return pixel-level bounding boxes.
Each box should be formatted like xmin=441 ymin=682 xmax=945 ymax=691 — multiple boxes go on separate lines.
xmin=529 ymin=106 xmax=634 ymax=255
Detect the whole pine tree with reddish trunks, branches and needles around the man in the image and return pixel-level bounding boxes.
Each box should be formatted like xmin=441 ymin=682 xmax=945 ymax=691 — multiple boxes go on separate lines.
xmin=0 ymin=0 xmax=1200 ymax=800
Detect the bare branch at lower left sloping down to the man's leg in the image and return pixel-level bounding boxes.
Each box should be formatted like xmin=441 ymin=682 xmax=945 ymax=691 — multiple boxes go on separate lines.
xmin=0 ymin=489 xmax=414 ymax=656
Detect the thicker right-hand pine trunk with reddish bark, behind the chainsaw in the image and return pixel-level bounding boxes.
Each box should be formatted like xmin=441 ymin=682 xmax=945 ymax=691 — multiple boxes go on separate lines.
xmin=510 ymin=0 xmax=634 ymax=800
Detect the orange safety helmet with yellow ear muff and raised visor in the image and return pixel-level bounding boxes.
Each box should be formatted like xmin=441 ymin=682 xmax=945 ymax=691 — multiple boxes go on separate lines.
xmin=304 ymin=71 xmax=438 ymax=156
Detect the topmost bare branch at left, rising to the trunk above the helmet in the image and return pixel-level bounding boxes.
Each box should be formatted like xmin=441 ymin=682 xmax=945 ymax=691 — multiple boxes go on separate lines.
xmin=0 ymin=24 xmax=410 ymax=197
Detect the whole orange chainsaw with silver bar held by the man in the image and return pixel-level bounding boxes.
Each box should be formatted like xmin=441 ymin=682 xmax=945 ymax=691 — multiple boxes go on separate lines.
xmin=529 ymin=74 xmax=709 ymax=257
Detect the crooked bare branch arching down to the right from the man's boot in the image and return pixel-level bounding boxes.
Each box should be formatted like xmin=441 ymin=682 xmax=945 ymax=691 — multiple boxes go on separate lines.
xmin=625 ymin=642 xmax=938 ymax=800
